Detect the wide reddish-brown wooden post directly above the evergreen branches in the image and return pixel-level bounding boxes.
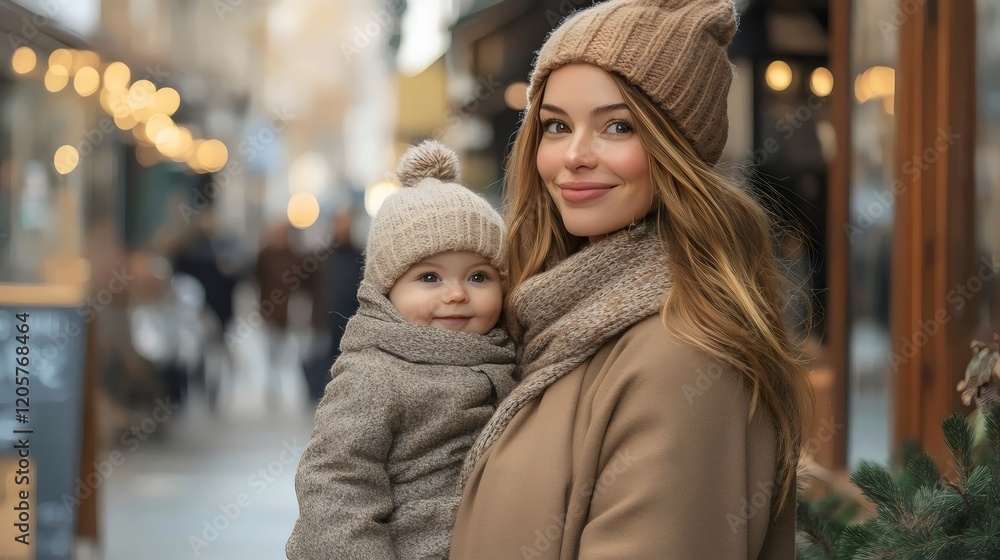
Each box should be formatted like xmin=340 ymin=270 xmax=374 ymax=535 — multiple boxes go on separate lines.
xmin=891 ymin=0 xmax=977 ymax=472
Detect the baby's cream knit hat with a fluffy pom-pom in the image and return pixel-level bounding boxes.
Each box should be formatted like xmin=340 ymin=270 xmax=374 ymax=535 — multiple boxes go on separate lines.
xmin=364 ymin=140 xmax=507 ymax=294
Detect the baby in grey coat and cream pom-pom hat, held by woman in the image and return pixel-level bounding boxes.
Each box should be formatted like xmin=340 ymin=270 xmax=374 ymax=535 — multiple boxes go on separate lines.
xmin=285 ymin=141 xmax=514 ymax=560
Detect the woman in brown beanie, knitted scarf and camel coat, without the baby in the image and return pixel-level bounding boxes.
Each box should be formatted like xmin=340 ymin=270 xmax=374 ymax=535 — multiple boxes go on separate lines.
xmin=451 ymin=0 xmax=807 ymax=560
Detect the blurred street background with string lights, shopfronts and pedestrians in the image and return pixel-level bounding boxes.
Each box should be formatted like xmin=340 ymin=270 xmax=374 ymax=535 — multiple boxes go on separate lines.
xmin=0 ymin=0 xmax=1000 ymax=560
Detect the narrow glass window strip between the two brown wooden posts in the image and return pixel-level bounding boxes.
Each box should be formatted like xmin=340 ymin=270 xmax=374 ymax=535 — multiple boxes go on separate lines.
xmin=844 ymin=0 xmax=899 ymax=469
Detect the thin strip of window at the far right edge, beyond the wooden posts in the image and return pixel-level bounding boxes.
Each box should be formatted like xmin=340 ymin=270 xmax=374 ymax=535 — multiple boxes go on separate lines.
xmin=975 ymin=0 xmax=1000 ymax=335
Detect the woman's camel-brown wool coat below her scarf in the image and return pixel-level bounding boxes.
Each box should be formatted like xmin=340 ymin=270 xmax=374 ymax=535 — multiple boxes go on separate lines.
xmin=450 ymin=315 xmax=795 ymax=560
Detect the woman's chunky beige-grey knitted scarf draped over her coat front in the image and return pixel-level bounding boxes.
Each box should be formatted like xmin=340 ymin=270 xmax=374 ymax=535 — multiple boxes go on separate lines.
xmin=460 ymin=220 xmax=672 ymax=486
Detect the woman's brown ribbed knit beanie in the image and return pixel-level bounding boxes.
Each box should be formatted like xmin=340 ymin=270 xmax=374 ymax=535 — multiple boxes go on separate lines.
xmin=528 ymin=0 xmax=736 ymax=164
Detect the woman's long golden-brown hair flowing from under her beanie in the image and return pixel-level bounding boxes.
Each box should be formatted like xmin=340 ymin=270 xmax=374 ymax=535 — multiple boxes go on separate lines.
xmin=505 ymin=73 xmax=810 ymax=508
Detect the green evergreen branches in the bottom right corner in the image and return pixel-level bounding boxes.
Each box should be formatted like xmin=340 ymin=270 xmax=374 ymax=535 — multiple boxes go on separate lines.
xmin=796 ymin=404 xmax=1000 ymax=560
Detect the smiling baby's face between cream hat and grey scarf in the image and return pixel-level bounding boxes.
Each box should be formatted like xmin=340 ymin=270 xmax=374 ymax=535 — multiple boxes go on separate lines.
xmin=389 ymin=251 xmax=503 ymax=334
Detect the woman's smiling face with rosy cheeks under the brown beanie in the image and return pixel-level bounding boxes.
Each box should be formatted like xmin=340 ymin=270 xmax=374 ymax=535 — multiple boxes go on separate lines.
xmin=536 ymin=64 xmax=653 ymax=241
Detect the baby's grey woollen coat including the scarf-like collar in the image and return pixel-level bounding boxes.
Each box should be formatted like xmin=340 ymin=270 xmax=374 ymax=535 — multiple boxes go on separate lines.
xmin=286 ymin=282 xmax=514 ymax=560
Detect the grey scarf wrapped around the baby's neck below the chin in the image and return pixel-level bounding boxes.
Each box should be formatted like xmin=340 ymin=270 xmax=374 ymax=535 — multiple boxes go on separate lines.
xmin=342 ymin=281 xmax=514 ymax=397
